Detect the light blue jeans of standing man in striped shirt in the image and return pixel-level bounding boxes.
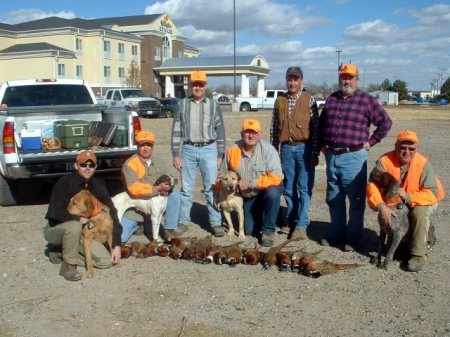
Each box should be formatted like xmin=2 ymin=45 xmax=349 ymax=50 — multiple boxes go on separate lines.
xmin=179 ymin=143 xmax=222 ymax=226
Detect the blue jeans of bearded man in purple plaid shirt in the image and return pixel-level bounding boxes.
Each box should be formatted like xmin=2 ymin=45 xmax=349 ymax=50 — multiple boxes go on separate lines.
xmin=326 ymin=149 xmax=368 ymax=243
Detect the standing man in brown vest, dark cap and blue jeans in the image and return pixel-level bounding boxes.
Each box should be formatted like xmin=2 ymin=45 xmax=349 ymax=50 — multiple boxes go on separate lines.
xmin=270 ymin=67 xmax=320 ymax=239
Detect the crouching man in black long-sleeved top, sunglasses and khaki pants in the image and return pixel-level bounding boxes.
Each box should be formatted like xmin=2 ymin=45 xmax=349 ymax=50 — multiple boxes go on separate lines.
xmin=44 ymin=150 xmax=122 ymax=281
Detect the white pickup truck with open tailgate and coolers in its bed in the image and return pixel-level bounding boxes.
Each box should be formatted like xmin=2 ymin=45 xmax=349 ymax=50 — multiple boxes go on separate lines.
xmin=0 ymin=79 xmax=141 ymax=206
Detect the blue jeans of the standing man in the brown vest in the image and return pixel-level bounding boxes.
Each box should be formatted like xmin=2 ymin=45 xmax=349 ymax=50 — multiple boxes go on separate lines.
xmin=280 ymin=142 xmax=315 ymax=230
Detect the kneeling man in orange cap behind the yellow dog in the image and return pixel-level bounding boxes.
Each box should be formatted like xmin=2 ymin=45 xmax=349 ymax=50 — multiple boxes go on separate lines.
xmin=222 ymin=118 xmax=283 ymax=247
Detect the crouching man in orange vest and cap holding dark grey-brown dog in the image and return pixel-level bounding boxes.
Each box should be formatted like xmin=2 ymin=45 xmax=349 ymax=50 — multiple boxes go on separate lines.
xmin=366 ymin=130 xmax=444 ymax=272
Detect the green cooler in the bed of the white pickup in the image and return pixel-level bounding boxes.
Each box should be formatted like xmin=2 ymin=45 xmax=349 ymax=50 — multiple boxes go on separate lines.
xmin=54 ymin=120 xmax=89 ymax=149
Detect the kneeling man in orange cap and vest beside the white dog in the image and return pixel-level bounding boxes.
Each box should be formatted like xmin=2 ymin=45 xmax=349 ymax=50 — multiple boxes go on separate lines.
xmin=120 ymin=130 xmax=187 ymax=242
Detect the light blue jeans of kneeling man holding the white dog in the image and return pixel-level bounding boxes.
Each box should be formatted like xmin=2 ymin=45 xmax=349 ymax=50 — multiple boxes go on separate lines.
xmin=120 ymin=190 xmax=181 ymax=242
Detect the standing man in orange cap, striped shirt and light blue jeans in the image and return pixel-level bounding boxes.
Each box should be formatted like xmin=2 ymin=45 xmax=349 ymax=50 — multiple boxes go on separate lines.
xmin=172 ymin=71 xmax=225 ymax=237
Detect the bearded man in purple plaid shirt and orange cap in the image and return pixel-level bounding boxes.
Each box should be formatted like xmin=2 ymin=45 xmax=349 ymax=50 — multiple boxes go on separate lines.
xmin=319 ymin=64 xmax=392 ymax=251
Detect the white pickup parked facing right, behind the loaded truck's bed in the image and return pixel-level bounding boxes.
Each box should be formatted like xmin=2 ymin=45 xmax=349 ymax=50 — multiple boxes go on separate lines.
xmin=98 ymin=88 xmax=161 ymax=117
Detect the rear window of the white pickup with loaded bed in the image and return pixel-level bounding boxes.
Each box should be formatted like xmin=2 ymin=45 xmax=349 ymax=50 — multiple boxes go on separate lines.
xmin=2 ymin=84 xmax=94 ymax=107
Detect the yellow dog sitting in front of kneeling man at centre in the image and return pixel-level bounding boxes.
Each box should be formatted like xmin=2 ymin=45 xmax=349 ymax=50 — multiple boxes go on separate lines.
xmin=217 ymin=171 xmax=245 ymax=239
